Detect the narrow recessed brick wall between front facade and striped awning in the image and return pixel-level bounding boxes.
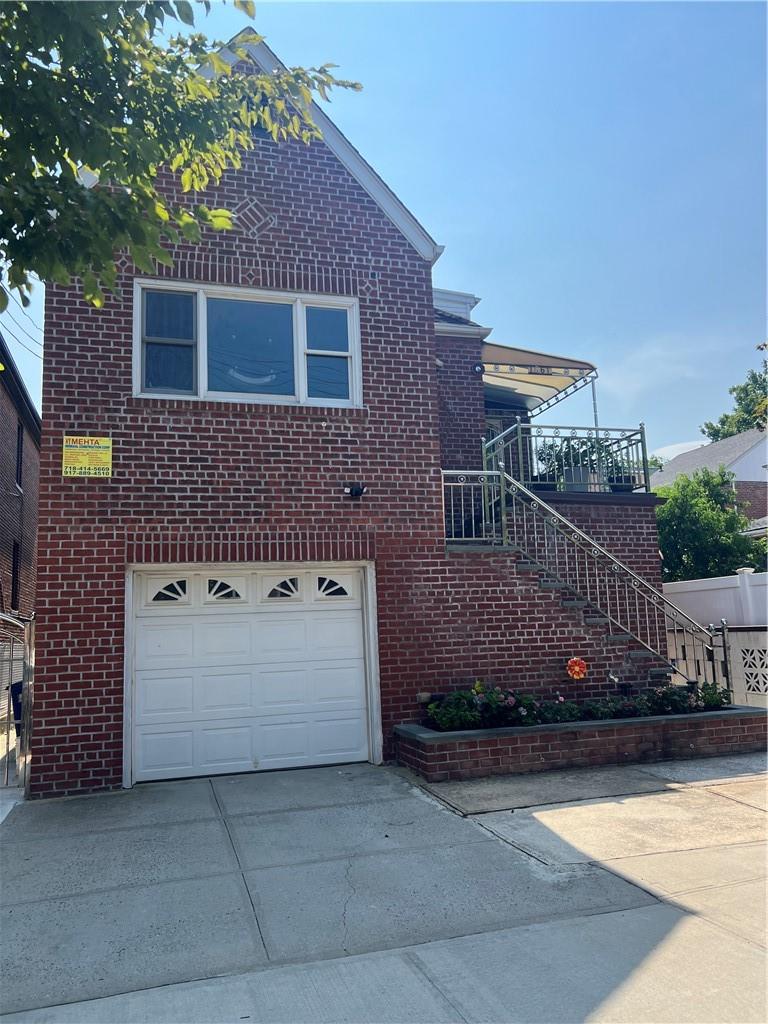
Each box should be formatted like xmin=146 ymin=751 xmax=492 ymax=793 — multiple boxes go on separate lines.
xmin=436 ymin=335 xmax=485 ymax=469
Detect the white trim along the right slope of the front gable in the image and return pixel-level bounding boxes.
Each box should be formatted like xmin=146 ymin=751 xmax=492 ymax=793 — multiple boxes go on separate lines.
xmin=219 ymin=36 xmax=444 ymax=263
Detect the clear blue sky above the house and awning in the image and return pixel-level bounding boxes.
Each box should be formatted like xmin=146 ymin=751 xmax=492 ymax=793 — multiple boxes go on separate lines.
xmin=2 ymin=2 xmax=766 ymax=449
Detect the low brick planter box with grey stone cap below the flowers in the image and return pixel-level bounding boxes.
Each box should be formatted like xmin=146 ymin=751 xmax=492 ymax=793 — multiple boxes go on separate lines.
xmin=394 ymin=708 xmax=768 ymax=782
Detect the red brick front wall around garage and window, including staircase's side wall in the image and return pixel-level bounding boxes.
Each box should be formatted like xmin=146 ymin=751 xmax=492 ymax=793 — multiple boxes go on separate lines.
xmin=31 ymin=130 xmax=656 ymax=795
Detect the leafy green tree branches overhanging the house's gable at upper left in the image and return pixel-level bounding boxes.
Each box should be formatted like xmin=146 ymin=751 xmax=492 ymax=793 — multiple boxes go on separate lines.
xmin=0 ymin=0 xmax=359 ymax=310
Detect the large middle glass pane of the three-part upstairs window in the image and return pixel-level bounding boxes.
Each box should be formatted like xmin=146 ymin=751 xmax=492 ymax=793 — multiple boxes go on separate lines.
xmin=208 ymin=299 xmax=295 ymax=395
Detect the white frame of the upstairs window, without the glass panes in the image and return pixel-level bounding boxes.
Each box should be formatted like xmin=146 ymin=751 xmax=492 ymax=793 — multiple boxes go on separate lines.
xmin=132 ymin=278 xmax=362 ymax=409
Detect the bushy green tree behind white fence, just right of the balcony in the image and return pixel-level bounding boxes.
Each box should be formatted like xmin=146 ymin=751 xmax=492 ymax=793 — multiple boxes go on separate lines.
xmin=656 ymin=467 xmax=765 ymax=583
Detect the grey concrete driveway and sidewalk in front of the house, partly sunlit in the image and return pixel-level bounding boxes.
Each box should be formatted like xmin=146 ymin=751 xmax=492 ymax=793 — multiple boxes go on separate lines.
xmin=0 ymin=759 xmax=765 ymax=1024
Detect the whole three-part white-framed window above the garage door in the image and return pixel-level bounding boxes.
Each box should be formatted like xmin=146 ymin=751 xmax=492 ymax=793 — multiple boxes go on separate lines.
xmin=133 ymin=280 xmax=362 ymax=407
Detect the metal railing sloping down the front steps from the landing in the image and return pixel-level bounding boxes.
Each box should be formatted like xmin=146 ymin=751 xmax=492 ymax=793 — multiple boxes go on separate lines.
xmin=443 ymin=464 xmax=728 ymax=687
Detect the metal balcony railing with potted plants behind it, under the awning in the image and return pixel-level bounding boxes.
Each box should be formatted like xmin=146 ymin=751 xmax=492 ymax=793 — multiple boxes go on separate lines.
xmin=484 ymin=422 xmax=650 ymax=494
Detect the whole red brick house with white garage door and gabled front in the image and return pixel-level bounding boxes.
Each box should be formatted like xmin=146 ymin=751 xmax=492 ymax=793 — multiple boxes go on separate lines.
xmin=30 ymin=39 xmax=720 ymax=796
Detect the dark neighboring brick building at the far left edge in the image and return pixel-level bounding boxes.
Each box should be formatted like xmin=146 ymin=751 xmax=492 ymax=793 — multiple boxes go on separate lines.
xmin=0 ymin=335 xmax=40 ymax=617
